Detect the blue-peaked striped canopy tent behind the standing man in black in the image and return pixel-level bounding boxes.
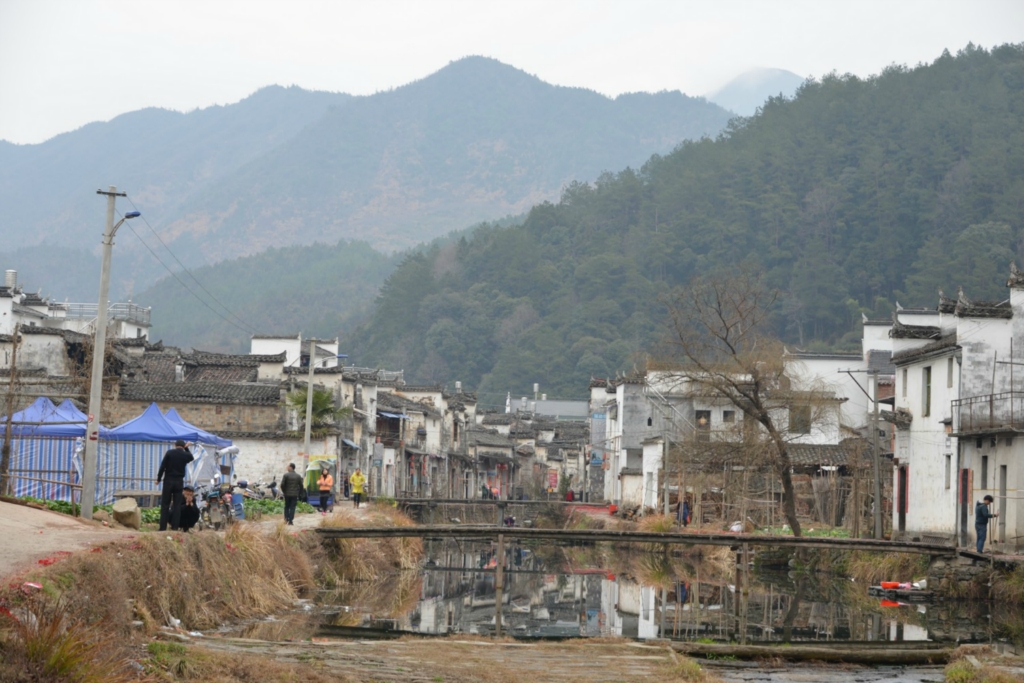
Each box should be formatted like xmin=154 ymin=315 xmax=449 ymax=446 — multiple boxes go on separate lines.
xmin=96 ymin=403 xmax=231 ymax=504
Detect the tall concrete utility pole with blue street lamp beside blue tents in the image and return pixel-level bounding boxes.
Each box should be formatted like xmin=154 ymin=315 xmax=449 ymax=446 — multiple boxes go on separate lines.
xmin=82 ymin=185 xmax=141 ymax=519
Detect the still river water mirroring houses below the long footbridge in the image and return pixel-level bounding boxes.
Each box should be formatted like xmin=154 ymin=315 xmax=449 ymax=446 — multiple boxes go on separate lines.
xmin=214 ymin=540 xmax=1024 ymax=683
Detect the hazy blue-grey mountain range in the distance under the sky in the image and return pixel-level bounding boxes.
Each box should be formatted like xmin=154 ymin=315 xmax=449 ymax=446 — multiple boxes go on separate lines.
xmin=0 ymin=57 xmax=731 ymax=305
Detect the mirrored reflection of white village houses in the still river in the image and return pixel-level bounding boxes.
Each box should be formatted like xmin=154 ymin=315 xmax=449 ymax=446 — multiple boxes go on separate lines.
xmin=329 ymin=541 xmax=991 ymax=642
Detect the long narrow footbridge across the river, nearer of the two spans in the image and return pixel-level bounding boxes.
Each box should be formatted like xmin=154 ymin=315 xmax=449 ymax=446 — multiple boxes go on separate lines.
xmin=316 ymin=524 xmax=957 ymax=556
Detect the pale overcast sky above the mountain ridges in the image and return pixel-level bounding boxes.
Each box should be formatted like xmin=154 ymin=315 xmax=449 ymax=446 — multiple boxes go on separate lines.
xmin=0 ymin=0 xmax=1024 ymax=143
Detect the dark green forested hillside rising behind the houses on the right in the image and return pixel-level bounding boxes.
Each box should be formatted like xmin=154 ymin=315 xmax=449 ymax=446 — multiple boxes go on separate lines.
xmin=349 ymin=45 xmax=1024 ymax=402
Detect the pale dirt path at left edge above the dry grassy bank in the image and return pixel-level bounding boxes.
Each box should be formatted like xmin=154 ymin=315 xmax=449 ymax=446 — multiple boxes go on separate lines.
xmin=0 ymin=502 xmax=135 ymax=578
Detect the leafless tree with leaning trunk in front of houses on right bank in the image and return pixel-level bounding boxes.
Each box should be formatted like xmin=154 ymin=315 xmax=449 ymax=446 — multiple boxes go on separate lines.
xmin=668 ymin=272 xmax=835 ymax=536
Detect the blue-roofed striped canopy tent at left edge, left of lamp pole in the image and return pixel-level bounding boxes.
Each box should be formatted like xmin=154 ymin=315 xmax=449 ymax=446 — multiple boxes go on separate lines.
xmin=0 ymin=396 xmax=110 ymax=501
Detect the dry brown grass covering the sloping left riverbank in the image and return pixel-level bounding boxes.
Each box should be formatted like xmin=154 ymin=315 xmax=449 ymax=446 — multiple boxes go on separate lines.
xmin=0 ymin=507 xmax=422 ymax=683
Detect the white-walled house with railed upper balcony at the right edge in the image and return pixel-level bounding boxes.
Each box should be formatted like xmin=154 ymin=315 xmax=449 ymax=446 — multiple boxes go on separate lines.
xmin=890 ymin=266 xmax=1024 ymax=549
